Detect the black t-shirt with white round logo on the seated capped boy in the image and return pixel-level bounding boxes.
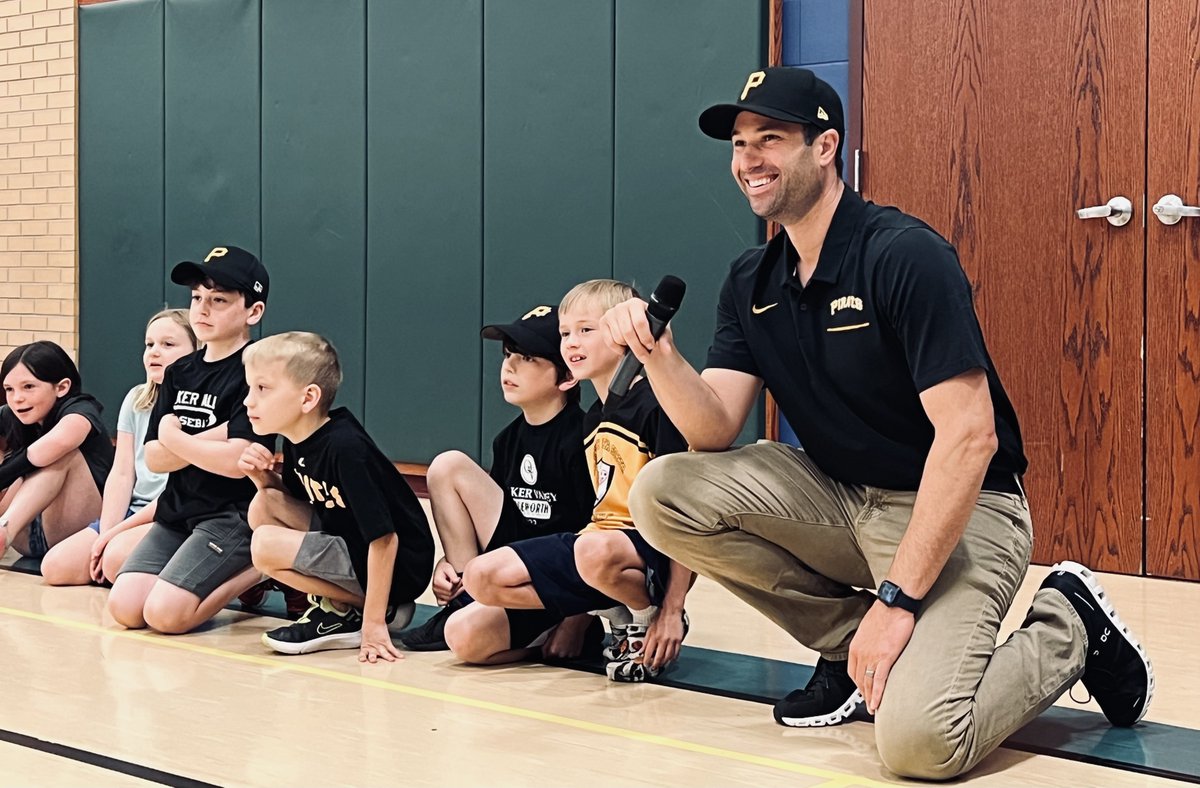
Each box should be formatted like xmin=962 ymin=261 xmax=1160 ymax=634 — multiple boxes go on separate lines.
xmin=490 ymin=404 xmax=595 ymax=534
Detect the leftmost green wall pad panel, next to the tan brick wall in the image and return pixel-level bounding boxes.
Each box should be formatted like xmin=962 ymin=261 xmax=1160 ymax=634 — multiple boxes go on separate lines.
xmin=79 ymin=0 xmax=164 ymax=426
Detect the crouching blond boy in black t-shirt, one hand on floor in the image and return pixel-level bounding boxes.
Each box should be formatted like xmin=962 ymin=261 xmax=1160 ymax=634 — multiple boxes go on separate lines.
xmin=239 ymin=331 xmax=433 ymax=662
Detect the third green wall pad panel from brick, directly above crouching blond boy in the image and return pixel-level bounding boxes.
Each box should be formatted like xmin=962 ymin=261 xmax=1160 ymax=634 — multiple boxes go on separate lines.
xmin=262 ymin=0 xmax=366 ymax=417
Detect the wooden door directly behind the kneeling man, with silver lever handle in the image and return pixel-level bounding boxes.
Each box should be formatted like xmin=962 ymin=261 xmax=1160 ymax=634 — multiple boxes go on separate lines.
xmin=863 ymin=0 xmax=1147 ymax=572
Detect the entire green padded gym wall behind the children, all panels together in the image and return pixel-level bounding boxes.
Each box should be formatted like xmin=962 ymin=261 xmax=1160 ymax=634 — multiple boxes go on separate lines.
xmin=79 ymin=0 xmax=766 ymax=462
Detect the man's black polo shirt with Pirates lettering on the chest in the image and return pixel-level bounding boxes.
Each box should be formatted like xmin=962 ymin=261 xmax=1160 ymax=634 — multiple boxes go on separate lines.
xmin=708 ymin=187 xmax=1027 ymax=492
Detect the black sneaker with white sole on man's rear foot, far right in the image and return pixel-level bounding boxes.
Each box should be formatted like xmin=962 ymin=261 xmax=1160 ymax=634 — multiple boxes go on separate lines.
xmin=1042 ymin=561 xmax=1154 ymax=728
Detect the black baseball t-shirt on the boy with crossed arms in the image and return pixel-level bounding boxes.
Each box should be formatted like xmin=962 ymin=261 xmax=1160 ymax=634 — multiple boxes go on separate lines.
xmin=145 ymin=345 xmax=275 ymax=531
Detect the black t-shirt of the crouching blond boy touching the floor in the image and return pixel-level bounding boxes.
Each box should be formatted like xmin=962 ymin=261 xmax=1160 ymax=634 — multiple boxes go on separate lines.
xmin=283 ymin=408 xmax=433 ymax=604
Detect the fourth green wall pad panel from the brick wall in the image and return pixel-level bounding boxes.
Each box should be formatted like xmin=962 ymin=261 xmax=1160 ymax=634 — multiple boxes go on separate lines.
xmin=365 ymin=0 xmax=484 ymax=462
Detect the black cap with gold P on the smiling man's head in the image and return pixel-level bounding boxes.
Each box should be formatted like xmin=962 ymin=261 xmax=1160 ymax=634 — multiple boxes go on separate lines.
xmin=700 ymin=67 xmax=846 ymax=143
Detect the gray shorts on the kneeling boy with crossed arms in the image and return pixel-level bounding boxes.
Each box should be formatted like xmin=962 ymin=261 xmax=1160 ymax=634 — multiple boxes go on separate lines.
xmin=120 ymin=510 xmax=251 ymax=600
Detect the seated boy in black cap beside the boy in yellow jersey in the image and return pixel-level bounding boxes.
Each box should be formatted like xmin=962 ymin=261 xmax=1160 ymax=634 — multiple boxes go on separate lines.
xmin=401 ymin=306 xmax=594 ymax=656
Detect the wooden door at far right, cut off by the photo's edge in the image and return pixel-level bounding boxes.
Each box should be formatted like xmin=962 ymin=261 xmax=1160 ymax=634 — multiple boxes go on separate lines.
xmin=1146 ymin=0 xmax=1200 ymax=579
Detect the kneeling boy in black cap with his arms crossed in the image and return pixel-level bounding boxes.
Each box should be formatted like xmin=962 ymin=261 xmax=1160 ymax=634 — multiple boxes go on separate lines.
xmin=108 ymin=246 xmax=275 ymax=633
